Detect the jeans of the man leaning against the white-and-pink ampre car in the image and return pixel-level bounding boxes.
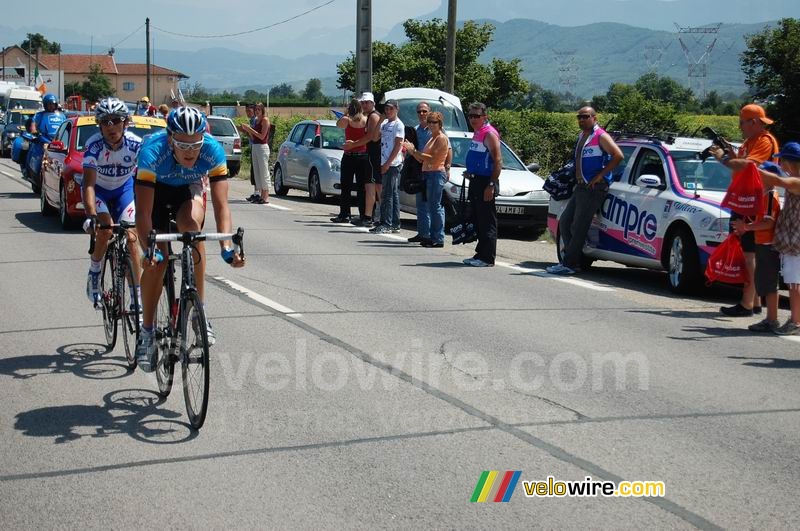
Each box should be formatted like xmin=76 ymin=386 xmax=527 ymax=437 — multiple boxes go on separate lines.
xmin=558 ymin=182 xmax=608 ymax=269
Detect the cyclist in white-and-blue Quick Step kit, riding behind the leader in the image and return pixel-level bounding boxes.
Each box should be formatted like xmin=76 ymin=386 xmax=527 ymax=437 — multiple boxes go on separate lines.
xmin=83 ymin=98 xmax=142 ymax=307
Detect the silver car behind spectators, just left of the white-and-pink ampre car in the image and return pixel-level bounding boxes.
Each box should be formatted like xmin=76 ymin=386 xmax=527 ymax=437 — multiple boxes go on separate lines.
xmin=400 ymin=131 xmax=550 ymax=231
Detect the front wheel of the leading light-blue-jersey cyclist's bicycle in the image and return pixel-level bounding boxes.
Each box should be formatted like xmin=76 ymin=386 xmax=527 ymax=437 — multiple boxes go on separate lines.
xmin=180 ymin=292 xmax=209 ymax=429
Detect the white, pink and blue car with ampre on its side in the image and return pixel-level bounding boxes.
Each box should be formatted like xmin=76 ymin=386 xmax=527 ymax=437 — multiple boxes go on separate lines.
xmin=548 ymin=135 xmax=731 ymax=292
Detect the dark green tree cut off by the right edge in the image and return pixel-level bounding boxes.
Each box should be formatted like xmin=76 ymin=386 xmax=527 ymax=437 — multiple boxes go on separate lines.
xmin=741 ymin=18 xmax=800 ymax=141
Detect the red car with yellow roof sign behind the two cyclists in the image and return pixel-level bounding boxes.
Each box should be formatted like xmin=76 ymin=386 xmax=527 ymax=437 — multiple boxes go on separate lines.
xmin=40 ymin=115 xmax=167 ymax=229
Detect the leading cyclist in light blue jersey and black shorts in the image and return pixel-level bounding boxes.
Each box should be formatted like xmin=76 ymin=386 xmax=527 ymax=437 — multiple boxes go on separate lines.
xmin=135 ymin=107 xmax=244 ymax=372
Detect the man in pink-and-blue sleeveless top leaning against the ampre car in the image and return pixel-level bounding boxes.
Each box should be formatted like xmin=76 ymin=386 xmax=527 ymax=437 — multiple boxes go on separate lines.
xmin=547 ymin=107 xmax=623 ymax=275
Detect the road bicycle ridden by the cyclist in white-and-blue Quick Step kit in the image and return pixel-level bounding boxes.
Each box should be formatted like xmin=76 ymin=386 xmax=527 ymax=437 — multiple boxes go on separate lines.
xmin=89 ymin=221 xmax=141 ymax=370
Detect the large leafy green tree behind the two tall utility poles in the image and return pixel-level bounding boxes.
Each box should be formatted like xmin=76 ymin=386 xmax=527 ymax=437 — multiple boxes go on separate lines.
xmin=336 ymin=19 xmax=528 ymax=107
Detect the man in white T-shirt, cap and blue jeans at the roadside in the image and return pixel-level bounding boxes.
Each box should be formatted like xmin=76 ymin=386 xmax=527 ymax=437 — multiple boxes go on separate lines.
xmin=370 ymin=100 xmax=405 ymax=234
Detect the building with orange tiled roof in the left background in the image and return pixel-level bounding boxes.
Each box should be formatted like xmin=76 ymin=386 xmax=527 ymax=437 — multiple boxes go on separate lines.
xmin=0 ymin=46 xmax=189 ymax=106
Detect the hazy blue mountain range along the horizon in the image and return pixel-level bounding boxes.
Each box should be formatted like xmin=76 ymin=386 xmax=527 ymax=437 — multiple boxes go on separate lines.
xmin=0 ymin=16 xmax=774 ymax=97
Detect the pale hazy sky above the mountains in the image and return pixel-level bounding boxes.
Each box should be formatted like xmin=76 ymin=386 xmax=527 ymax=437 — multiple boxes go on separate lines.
xmin=0 ymin=0 xmax=800 ymax=57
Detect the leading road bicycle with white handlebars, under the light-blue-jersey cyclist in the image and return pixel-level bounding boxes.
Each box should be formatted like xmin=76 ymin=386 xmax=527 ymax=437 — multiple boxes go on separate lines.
xmin=147 ymin=221 xmax=244 ymax=429
